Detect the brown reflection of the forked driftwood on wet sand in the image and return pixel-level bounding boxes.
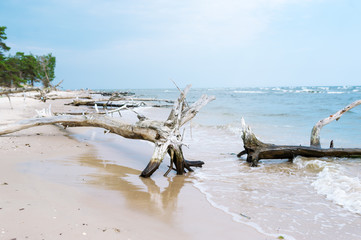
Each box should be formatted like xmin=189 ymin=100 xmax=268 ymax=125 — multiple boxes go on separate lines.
xmin=77 ymin=154 xmax=190 ymax=221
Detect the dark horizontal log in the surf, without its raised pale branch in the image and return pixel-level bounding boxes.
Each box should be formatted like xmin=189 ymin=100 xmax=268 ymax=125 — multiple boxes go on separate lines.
xmin=237 ymin=119 xmax=361 ymax=167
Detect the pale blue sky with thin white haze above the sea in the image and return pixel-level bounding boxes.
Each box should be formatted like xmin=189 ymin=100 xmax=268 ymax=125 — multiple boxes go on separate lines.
xmin=0 ymin=0 xmax=361 ymax=89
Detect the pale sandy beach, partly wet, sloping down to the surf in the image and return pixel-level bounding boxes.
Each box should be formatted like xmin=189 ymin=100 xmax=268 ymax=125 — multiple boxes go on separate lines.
xmin=0 ymin=94 xmax=272 ymax=240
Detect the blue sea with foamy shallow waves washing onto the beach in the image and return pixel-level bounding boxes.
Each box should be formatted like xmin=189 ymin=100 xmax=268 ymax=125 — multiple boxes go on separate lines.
xmin=107 ymin=86 xmax=361 ymax=240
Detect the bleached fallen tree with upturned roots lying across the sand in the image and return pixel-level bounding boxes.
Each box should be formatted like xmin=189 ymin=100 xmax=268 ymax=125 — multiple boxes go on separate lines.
xmin=0 ymin=85 xmax=215 ymax=177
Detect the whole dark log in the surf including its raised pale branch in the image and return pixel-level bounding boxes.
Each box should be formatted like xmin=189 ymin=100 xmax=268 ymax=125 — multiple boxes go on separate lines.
xmin=237 ymin=100 xmax=361 ymax=167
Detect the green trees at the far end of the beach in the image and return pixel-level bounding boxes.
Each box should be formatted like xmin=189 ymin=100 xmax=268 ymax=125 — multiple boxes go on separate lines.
xmin=0 ymin=26 xmax=56 ymax=88
